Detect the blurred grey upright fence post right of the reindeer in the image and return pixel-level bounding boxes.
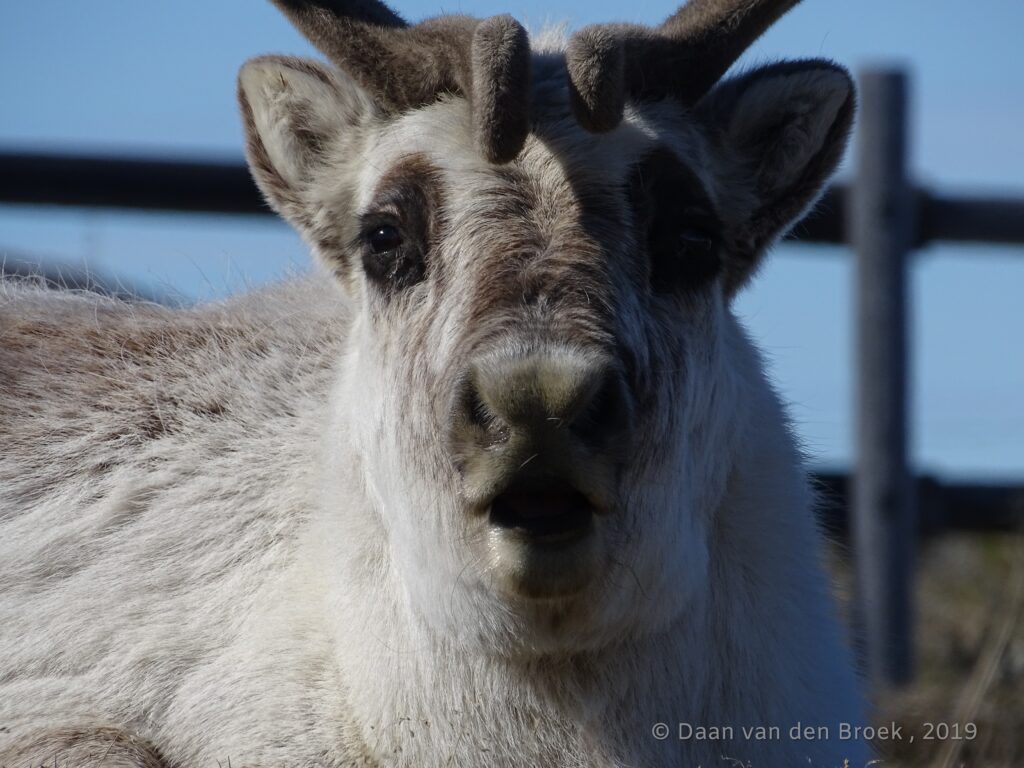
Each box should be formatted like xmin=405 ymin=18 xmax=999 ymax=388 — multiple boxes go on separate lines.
xmin=849 ymin=70 xmax=915 ymax=685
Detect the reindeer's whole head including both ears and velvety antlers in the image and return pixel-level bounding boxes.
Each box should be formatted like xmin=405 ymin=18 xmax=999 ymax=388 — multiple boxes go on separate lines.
xmin=240 ymin=0 xmax=854 ymax=650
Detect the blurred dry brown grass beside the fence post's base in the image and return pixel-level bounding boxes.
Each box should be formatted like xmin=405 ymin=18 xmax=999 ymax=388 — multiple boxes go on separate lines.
xmin=831 ymin=535 xmax=1024 ymax=768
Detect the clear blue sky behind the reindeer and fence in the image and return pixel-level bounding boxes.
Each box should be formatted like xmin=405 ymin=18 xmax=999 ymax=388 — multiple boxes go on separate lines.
xmin=0 ymin=0 xmax=1024 ymax=477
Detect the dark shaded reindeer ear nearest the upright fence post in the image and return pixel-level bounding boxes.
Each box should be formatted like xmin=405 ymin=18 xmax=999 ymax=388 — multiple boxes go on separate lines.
xmin=696 ymin=59 xmax=855 ymax=295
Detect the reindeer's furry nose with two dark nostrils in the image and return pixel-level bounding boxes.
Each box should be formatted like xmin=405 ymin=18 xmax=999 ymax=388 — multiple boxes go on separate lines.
xmin=466 ymin=350 xmax=627 ymax=449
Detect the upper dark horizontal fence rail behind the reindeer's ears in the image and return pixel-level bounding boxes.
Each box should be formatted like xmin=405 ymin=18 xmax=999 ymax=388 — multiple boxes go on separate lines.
xmin=0 ymin=152 xmax=1024 ymax=246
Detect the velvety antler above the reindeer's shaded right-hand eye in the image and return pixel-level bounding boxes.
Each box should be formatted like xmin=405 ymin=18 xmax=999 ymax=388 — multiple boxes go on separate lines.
xmin=566 ymin=0 xmax=800 ymax=131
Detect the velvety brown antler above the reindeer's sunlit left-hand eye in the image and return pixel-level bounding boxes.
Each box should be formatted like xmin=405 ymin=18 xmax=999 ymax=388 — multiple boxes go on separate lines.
xmin=272 ymin=0 xmax=529 ymax=163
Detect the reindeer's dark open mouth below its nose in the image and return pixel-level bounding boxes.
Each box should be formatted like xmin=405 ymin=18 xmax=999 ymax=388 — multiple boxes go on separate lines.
xmin=490 ymin=482 xmax=594 ymax=544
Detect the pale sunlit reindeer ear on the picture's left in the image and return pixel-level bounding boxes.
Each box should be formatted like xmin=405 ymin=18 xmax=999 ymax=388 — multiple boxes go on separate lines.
xmin=239 ymin=56 xmax=376 ymax=230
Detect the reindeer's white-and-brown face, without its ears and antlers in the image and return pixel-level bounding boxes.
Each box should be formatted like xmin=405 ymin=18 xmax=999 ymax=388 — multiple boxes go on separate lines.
xmin=340 ymin=96 xmax=722 ymax=618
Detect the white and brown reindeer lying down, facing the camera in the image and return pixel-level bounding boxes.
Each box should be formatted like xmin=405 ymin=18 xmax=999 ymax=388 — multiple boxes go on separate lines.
xmin=0 ymin=0 xmax=867 ymax=768
